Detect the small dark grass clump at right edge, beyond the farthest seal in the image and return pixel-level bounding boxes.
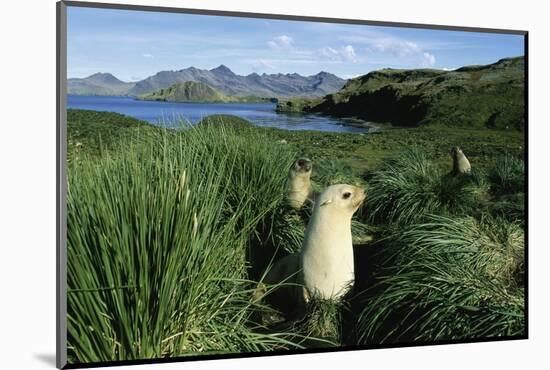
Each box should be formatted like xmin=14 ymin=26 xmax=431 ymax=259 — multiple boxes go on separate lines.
xmin=489 ymin=153 xmax=525 ymax=194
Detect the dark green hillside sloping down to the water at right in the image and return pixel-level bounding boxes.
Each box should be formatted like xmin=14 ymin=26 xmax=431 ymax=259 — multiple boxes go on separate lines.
xmin=277 ymin=57 xmax=525 ymax=130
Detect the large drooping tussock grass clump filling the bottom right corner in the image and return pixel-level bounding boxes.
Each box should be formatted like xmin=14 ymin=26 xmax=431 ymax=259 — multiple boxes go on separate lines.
xmin=358 ymin=216 xmax=525 ymax=344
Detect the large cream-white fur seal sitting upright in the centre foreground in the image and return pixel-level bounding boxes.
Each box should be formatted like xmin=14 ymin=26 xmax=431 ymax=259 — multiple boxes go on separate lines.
xmin=262 ymin=184 xmax=365 ymax=305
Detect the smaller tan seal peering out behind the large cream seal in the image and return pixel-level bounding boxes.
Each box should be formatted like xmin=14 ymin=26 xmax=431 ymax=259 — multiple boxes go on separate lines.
xmin=286 ymin=158 xmax=313 ymax=210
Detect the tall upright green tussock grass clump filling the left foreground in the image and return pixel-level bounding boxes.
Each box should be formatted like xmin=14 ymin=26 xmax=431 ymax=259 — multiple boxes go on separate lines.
xmin=67 ymin=119 xmax=306 ymax=363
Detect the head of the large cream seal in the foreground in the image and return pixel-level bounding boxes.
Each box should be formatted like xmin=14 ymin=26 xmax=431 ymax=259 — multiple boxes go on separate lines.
xmin=316 ymin=184 xmax=366 ymax=218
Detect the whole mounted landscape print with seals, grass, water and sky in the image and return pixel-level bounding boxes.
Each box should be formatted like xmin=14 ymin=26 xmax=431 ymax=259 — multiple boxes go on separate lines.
xmin=58 ymin=2 xmax=528 ymax=367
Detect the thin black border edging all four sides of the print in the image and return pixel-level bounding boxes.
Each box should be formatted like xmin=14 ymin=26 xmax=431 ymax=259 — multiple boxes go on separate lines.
xmin=56 ymin=0 xmax=529 ymax=369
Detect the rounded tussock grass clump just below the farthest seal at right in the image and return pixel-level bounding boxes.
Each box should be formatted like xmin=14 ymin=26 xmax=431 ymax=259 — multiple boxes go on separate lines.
xmin=366 ymin=150 xmax=487 ymax=224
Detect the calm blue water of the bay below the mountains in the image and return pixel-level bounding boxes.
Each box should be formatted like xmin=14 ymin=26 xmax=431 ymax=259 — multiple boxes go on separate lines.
xmin=67 ymin=95 xmax=369 ymax=132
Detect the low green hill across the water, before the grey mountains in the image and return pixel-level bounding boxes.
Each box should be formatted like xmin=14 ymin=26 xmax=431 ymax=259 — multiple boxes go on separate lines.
xmin=138 ymin=81 xmax=269 ymax=103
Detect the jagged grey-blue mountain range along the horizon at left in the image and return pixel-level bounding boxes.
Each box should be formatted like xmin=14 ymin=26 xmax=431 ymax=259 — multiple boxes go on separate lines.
xmin=67 ymin=64 xmax=346 ymax=98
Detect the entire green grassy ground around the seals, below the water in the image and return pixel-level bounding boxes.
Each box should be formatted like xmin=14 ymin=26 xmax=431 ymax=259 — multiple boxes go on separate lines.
xmin=68 ymin=110 xmax=525 ymax=362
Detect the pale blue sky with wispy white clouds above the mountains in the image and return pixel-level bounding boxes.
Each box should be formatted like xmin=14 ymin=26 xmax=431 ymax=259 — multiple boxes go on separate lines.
xmin=67 ymin=7 xmax=524 ymax=81
